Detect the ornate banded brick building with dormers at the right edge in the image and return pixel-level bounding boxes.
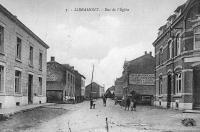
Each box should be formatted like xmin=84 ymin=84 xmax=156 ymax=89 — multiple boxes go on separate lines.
xmin=153 ymin=0 xmax=200 ymax=109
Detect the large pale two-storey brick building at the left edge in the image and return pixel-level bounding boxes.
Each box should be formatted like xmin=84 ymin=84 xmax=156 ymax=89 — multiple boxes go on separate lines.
xmin=0 ymin=5 xmax=49 ymax=108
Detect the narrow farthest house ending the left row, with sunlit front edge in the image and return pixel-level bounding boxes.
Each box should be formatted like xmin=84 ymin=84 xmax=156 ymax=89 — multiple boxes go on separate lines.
xmin=74 ymin=70 xmax=85 ymax=102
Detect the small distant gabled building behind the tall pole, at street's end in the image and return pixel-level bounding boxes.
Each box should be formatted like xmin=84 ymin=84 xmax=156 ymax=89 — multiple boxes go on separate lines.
xmin=85 ymin=82 xmax=104 ymax=99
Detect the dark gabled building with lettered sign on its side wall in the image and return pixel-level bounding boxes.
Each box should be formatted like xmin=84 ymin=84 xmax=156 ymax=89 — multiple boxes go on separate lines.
xmin=123 ymin=52 xmax=155 ymax=104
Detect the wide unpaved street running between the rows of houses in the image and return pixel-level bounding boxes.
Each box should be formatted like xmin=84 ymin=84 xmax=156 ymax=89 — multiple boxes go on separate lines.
xmin=0 ymin=99 xmax=200 ymax=132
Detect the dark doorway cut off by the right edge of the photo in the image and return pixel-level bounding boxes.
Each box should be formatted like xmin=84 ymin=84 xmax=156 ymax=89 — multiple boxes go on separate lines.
xmin=193 ymin=68 xmax=200 ymax=106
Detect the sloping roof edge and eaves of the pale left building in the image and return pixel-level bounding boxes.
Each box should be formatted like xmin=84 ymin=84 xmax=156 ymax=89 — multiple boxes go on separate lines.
xmin=0 ymin=4 xmax=49 ymax=49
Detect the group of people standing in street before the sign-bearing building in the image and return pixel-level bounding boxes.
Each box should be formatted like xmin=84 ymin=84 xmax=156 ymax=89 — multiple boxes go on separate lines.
xmin=125 ymin=97 xmax=136 ymax=111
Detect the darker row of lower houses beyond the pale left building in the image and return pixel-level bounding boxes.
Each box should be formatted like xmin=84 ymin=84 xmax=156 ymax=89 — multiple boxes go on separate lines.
xmin=46 ymin=57 xmax=85 ymax=102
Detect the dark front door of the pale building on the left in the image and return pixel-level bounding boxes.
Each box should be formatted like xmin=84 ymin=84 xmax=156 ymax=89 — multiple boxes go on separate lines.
xmin=28 ymin=75 xmax=33 ymax=104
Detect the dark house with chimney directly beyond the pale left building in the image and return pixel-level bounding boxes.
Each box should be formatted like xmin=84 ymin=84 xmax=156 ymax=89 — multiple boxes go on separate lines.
xmin=47 ymin=57 xmax=75 ymax=102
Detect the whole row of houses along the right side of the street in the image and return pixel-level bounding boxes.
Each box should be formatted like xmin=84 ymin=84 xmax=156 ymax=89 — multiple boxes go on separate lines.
xmin=115 ymin=0 xmax=200 ymax=110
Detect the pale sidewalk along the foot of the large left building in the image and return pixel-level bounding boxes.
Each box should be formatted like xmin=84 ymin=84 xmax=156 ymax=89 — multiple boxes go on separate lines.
xmin=0 ymin=103 xmax=54 ymax=118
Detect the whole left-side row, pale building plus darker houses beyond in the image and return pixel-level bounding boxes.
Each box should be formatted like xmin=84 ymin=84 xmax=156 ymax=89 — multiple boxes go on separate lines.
xmin=0 ymin=5 xmax=85 ymax=109
